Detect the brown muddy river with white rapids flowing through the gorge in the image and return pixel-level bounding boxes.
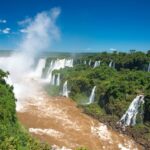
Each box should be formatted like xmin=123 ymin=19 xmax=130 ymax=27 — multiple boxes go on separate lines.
xmin=17 ymin=86 xmax=142 ymax=150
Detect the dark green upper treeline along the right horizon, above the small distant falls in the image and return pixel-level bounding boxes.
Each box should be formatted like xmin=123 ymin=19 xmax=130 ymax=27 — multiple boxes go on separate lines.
xmin=75 ymin=50 xmax=150 ymax=71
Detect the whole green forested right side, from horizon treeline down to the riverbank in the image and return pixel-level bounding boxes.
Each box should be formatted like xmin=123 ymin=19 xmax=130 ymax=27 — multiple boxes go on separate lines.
xmin=44 ymin=50 xmax=150 ymax=146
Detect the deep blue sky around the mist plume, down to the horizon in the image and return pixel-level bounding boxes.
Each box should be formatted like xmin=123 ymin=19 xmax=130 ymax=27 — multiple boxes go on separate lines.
xmin=0 ymin=0 xmax=150 ymax=52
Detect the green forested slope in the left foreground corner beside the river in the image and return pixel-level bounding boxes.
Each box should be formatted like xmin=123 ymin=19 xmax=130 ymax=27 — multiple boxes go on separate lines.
xmin=0 ymin=70 xmax=50 ymax=150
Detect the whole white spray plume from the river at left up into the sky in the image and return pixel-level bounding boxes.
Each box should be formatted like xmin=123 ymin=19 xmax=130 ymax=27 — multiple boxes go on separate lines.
xmin=0 ymin=8 xmax=60 ymax=110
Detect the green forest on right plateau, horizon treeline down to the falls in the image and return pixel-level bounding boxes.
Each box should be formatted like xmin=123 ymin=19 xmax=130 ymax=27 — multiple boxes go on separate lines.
xmin=53 ymin=51 xmax=150 ymax=122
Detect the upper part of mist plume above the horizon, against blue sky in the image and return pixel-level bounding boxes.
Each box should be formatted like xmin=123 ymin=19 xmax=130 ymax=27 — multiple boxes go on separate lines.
xmin=19 ymin=8 xmax=60 ymax=55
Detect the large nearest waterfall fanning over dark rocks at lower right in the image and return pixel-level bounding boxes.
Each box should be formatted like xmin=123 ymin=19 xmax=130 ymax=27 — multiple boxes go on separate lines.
xmin=118 ymin=95 xmax=144 ymax=126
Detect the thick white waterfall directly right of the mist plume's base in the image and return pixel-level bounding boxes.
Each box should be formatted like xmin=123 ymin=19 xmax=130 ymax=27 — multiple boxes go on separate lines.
xmin=35 ymin=58 xmax=46 ymax=77
